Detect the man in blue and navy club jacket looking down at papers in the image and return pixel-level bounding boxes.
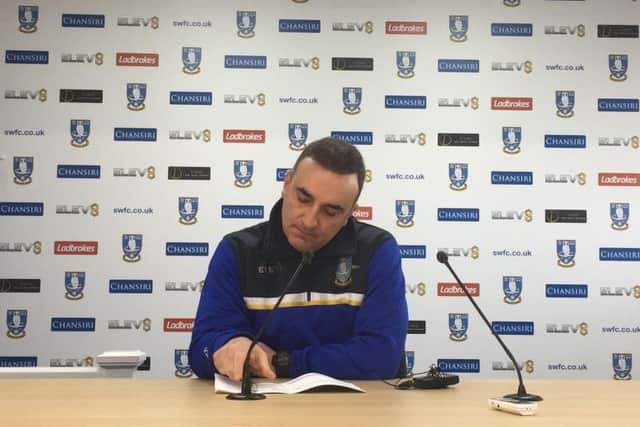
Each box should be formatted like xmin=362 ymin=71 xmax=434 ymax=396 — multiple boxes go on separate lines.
xmin=189 ymin=138 xmax=408 ymax=380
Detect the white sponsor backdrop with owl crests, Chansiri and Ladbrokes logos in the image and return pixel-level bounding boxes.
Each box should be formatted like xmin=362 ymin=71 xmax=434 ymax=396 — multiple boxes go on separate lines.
xmin=0 ymin=0 xmax=640 ymax=380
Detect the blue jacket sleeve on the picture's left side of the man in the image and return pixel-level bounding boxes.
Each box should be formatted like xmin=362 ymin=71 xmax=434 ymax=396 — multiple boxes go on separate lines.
xmin=189 ymin=240 xmax=253 ymax=378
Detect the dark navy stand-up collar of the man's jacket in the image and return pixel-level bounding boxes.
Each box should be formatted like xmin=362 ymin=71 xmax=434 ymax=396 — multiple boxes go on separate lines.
xmin=263 ymin=198 xmax=356 ymax=258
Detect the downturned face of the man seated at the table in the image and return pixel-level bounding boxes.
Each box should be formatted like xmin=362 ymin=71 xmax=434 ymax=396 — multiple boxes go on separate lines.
xmin=282 ymin=157 xmax=358 ymax=252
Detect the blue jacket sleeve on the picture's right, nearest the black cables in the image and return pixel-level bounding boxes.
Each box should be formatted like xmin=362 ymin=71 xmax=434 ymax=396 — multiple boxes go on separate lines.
xmin=289 ymin=239 xmax=408 ymax=379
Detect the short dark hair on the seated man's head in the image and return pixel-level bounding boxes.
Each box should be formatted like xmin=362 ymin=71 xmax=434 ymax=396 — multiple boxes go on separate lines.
xmin=292 ymin=137 xmax=365 ymax=200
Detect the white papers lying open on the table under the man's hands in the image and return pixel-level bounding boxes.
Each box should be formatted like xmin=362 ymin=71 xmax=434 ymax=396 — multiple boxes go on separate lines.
xmin=215 ymin=372 xmax=364 ymax=394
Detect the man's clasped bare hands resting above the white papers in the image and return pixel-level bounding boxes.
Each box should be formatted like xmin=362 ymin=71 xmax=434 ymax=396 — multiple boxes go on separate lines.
xmin=213 ymin=337 xmax=276 ymax=381
